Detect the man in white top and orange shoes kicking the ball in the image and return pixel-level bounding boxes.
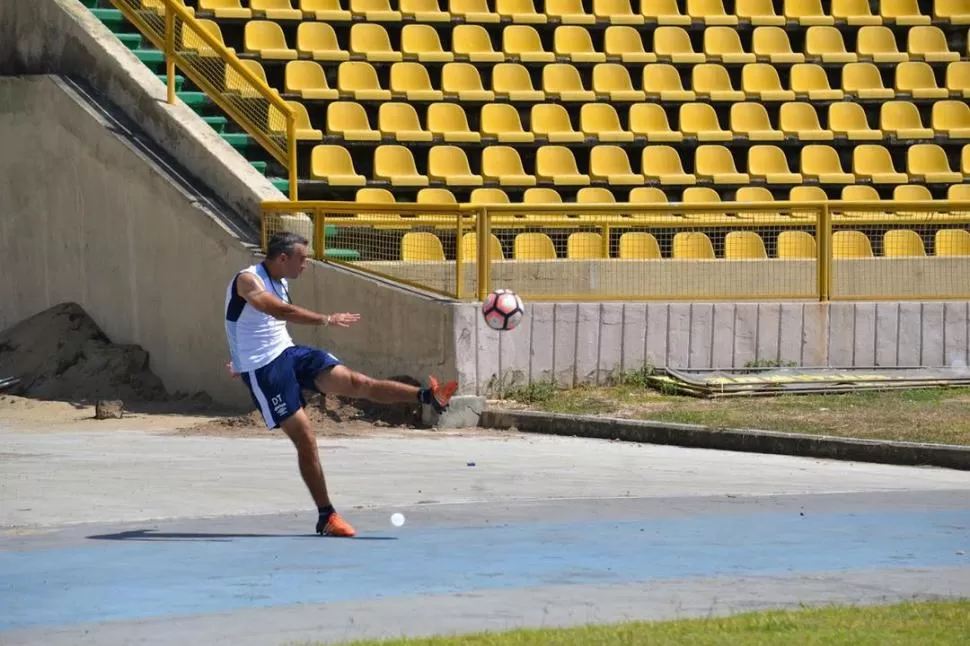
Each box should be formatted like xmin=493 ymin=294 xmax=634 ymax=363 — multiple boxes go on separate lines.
xmin=226 ymin=232 xmax=458 ymax=536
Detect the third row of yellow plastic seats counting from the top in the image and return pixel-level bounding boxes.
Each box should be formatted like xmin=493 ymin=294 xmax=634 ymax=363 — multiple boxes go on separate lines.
xmin=270 ymin=61 xmax=970 ymax=103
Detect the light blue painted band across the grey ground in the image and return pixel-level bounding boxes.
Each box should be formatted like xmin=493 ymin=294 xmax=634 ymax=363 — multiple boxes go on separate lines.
xmin=0 ymin=509 xmax=970 ymax=630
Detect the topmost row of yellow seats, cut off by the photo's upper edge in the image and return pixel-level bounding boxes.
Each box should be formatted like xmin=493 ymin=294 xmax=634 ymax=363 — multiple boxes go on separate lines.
xmin=191 ymin=0 xmax=970 ymax=25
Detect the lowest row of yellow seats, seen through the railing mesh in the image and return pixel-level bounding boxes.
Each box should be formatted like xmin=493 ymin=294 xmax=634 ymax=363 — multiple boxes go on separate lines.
xmin=401 ymin=229 xmax=970 ymax=262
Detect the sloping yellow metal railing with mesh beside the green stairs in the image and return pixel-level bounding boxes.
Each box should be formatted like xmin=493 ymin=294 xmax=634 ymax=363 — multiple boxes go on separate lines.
xmin=111 ymin=0 xmax=298 ymax=201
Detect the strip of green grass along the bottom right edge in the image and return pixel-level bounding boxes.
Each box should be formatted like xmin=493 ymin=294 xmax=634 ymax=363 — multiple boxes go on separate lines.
xmin=328 ymin=601 xmax=970 ymax=646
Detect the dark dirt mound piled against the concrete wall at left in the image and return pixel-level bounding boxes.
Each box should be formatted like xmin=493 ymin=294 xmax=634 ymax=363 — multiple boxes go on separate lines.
xmin=0 ymin=303 xmax=168 ymax=404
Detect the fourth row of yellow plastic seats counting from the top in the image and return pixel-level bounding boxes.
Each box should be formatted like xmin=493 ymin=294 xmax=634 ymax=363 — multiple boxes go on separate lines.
xmin=308 ymin=101 xmax=970 ymax=144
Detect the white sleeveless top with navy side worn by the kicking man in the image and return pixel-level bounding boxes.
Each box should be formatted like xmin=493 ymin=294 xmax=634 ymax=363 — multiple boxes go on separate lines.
xmin=226 ymin=263 xmax=294 ymax=373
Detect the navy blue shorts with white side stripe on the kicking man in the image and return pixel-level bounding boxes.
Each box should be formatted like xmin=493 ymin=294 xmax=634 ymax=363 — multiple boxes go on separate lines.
xmin=242 ymin=345 xmax=341 ymax=428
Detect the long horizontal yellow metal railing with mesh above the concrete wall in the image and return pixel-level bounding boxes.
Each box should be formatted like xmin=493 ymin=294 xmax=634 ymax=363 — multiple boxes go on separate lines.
xmin=263 ymin=201 xmax=970 ymax=301
